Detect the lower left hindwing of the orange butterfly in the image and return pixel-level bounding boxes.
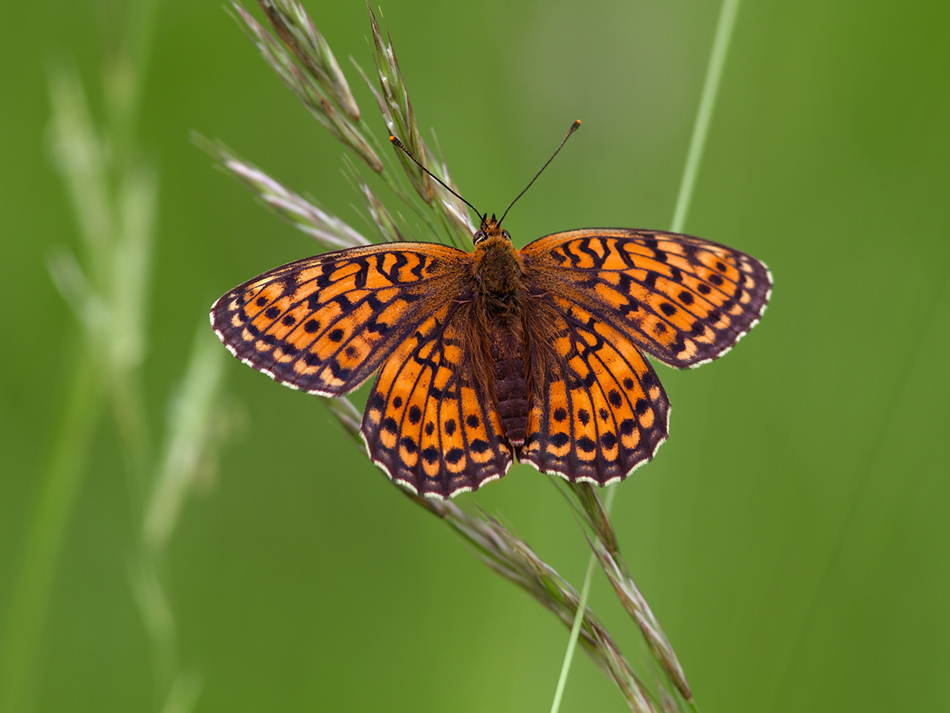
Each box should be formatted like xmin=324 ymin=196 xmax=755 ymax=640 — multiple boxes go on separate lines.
xmin=363 ymin=300 xmax=512 ymax=498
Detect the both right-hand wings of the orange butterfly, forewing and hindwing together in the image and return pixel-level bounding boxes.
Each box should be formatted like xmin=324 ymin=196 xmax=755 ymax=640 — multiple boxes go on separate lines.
xmin=518 ymin=229 xmax=772 ymax=485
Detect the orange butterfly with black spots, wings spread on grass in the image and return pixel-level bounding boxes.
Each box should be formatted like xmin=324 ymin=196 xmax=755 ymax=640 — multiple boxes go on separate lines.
xmin=211 ymin=214 xmax=772 ymax=498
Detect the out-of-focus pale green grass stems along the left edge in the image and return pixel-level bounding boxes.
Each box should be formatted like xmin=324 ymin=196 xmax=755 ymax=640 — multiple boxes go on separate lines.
xmin=0 ymin=0 xmax=222 ymax=713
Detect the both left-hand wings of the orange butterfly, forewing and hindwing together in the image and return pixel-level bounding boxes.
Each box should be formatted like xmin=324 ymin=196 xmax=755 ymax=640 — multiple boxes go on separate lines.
xmin=211 ymin=243 xmax=512 ymax=497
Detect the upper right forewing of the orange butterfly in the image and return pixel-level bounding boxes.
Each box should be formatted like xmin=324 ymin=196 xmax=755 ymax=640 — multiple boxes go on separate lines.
xmin=521 ymin=229 xmax=772 ymax=368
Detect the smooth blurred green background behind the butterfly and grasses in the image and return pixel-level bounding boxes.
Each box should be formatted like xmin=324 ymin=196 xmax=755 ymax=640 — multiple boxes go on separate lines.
xmin=0 ymin=0 xmax=950 ymax=713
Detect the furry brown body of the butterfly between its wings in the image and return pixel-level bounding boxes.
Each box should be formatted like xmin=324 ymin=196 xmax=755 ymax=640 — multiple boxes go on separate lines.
xmin=472 ymin=216 xmax=528 ymax=448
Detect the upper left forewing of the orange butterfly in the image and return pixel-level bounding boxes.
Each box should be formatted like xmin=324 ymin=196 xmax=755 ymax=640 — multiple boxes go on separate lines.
xmin=211 ymin=243 xmax=471 ymax=396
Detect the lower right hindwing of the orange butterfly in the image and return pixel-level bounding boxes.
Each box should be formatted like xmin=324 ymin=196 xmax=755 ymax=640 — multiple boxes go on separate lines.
xmin=518 ymin=293 xmax=670 ymax=485
